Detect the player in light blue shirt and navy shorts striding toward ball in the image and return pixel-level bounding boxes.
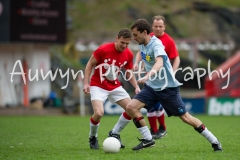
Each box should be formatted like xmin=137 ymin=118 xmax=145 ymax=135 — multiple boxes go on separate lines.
xmin=126 ymin=19 xmax=222 ymax=151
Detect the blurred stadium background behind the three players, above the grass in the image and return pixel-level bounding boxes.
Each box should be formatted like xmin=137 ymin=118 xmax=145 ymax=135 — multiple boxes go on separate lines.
xmin=0 ymin=0 xmax=240 ymax=116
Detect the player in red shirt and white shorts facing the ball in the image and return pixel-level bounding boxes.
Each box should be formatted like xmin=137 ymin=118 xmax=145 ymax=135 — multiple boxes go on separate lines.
xmin=83 ymin=29 xmax=140 ymax=149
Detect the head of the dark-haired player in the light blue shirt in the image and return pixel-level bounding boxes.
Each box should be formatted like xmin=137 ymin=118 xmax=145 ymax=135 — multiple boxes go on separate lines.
xmin=131 ymin=19 xmax=151 ymax=44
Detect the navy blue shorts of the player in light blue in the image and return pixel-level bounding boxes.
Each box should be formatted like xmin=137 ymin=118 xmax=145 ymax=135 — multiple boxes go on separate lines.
xmin=133 ymin=84 xmax=187 ymax=117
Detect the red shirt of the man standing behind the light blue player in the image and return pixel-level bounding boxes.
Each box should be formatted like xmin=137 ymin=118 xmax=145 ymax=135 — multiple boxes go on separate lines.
xmin=150 ymin=32 xmax=179 ymax=59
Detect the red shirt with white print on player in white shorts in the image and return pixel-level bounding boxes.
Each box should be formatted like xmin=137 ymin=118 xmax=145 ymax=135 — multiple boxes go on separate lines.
xmin=90 ymin=43 xmax=133 ymax=91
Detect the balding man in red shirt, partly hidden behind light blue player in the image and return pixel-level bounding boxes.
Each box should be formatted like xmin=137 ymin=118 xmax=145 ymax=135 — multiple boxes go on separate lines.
xmin=134 ymin=15 xmax=180 ymax=139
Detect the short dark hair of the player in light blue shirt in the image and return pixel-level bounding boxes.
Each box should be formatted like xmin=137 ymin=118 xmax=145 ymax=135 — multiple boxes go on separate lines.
xmin=131 ymin=19 xmax=151 ymax=34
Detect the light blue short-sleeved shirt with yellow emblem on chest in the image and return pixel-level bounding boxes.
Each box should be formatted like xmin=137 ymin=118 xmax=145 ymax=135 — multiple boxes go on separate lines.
xmin=140 ymin=36 xmax=182 ymax=91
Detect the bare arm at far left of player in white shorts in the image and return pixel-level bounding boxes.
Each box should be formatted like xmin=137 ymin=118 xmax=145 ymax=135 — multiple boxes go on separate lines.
xmin=83 ymin=55 xmax=97 ymax=93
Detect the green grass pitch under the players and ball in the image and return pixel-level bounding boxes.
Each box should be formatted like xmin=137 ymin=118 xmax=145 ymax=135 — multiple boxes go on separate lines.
xmin=0 ymin=115 xmax=240 ymax=160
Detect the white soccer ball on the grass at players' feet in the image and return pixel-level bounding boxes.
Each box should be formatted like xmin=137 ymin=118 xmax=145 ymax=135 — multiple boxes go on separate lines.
xmin=103 ymin=137 xmax=121 ymax=153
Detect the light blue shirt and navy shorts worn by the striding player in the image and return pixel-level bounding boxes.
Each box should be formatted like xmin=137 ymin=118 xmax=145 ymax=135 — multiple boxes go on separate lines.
xmin=133 ymin=36 xmax=187 ymax=116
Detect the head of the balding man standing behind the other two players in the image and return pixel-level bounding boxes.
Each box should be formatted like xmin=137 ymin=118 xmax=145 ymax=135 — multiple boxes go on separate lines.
xmin=152 ymin=15 xmax=166 ymax=37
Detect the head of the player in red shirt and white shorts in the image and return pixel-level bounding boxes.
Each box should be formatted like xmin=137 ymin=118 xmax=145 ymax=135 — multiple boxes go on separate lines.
xmin=115 ymin=28 xmax=132 ymax=52
